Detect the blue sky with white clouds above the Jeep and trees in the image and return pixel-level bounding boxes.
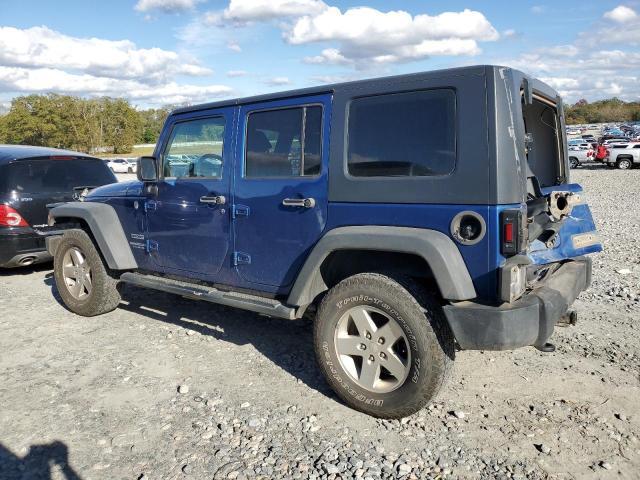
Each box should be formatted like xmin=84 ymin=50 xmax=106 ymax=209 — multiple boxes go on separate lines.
xmin=0 ymin=0 xmax=640 ymax=108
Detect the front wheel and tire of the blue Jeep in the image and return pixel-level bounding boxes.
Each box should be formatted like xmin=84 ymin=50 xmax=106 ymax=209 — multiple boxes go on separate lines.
xmin=53 ymin=229 xmax=120 ymax=317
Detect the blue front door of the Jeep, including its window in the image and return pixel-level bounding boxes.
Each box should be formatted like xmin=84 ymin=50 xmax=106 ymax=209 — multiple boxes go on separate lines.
xmin=145 ymin=108 xmax=234 ymax=281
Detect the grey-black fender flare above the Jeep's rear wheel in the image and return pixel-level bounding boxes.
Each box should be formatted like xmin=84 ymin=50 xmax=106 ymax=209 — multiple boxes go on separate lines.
xmin=287 ymin=225 xmax=476 ymax=307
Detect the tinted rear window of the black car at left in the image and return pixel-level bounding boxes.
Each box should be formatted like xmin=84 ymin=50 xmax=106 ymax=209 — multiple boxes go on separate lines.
xmin=0 ymin=159 xmax=117 ymax=193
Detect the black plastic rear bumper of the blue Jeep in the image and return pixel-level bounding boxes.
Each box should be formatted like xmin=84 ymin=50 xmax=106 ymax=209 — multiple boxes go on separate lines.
xmin=444 ymin=257 xmax=591 ymax=350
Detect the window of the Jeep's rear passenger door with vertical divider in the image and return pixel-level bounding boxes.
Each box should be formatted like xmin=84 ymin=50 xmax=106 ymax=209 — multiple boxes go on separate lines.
xmin=245 ymin=106 xmax=322 ymax=178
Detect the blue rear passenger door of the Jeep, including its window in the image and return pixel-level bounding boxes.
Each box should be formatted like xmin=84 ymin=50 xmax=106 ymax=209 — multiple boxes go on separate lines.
xmin=233 ymin=95 xmax=331 ymax=291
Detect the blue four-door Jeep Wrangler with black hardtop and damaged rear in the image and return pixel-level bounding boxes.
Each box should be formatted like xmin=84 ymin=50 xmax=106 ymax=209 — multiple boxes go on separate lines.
xmin=47 ymin=66 xmax=602 ymax=418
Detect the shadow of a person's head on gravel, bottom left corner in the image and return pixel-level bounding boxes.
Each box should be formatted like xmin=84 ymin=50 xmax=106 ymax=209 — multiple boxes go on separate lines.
xmin=0 ymin=441 xmax=81 ymax=480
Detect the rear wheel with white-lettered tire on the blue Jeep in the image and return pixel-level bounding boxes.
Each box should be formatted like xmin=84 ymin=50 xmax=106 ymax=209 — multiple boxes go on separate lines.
xmin=314 ymin=273 xmax=455 ymax=418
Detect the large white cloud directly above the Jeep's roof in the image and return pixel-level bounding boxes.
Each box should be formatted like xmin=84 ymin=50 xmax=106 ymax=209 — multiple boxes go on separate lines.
xmin=284 ymin=7 xmax=499 ymax=66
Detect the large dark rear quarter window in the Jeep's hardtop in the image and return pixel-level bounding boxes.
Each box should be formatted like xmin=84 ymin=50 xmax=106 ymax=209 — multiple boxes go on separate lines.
xmin=347 ymin=89 xmax=456 ymax=177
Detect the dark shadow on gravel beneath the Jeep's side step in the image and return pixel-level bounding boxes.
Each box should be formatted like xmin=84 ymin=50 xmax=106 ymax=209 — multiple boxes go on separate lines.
xmin=119 ymin=285 xmax=339 ymax=402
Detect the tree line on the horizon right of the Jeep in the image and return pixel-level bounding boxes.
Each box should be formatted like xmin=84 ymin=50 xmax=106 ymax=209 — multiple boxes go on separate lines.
xmin=564 ymin=98 xmax=640 ymax=125
